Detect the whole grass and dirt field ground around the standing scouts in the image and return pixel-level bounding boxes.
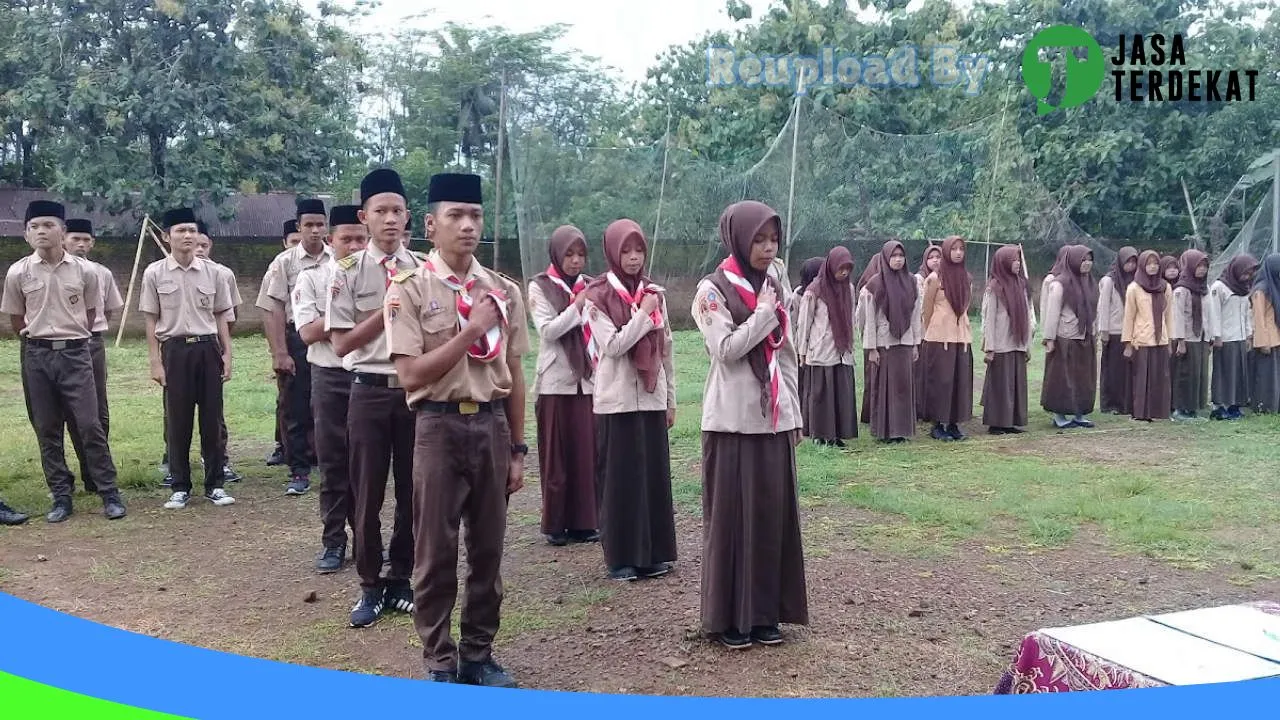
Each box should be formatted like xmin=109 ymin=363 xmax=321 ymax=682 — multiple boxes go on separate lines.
xmin=0 ymin=332 xmax=1280 ymax=694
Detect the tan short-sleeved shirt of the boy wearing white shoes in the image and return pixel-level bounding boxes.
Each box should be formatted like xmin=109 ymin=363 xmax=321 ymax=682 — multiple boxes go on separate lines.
xmin=138 ymin=255 xmax=232 ymax=342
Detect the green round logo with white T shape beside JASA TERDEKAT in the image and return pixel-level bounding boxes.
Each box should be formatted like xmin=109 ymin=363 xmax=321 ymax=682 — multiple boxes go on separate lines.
xmin=1023 ymin=26 xmax=1106 ymax=115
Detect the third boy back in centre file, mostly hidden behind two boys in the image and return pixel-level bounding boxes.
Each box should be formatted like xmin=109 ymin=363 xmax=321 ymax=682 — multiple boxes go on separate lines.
xmin=293 ymin=205 xmax=369 ymax=574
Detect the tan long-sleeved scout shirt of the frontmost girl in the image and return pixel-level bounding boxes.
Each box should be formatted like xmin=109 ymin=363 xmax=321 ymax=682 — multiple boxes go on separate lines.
xmin=691 ymin=279 xmax=800 ymax=434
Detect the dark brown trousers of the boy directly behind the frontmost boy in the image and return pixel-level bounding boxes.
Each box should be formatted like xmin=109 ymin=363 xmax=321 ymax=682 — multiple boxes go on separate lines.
xmin=347 ymin=383 xmax=413 ymax=589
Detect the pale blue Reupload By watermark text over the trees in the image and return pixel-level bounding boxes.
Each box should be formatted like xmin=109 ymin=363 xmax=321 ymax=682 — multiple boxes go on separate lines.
xmin=707 ymin=45 xmax=992 ymax=95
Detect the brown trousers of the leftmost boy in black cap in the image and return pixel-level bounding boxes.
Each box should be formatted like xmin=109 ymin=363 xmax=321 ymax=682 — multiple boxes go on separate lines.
xmin=22 ymin=342 xmax=116 ymax=501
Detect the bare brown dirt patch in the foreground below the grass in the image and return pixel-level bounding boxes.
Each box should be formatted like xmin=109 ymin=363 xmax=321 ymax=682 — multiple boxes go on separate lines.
xmin=0 ymin=443 xmax=1280 ymax=697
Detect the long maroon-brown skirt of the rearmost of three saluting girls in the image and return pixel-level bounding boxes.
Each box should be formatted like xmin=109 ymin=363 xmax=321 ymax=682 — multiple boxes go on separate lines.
xmin=534 ymin=395 xmax=596 ymax=536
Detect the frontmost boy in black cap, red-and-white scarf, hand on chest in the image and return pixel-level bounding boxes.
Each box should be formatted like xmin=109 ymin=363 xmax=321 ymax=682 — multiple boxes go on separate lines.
xmin=384 ymin=174 xmax=529 ymax=688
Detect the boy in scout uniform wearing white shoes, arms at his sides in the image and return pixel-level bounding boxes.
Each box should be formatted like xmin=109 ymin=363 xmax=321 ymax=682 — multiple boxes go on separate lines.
xmin=138 ymin=208 xmax=236 ymax=510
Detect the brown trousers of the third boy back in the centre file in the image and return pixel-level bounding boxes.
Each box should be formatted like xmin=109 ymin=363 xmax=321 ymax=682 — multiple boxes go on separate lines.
xmin=311 ymin=365 xmax=356 ymax=547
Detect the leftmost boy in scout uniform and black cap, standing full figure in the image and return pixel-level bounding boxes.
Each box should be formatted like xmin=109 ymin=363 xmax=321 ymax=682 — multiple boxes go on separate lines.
xmin=0 ymin=200 xmax=125 ymax=523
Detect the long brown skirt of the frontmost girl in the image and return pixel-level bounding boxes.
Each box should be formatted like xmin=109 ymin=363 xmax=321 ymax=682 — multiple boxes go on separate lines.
xmin=701 ymin=433 xmax=809 ymax=633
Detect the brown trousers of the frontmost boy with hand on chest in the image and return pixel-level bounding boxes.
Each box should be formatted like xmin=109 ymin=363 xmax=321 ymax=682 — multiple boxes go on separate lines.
xmin=413 ymin=402 xmax=511 ymax=671
